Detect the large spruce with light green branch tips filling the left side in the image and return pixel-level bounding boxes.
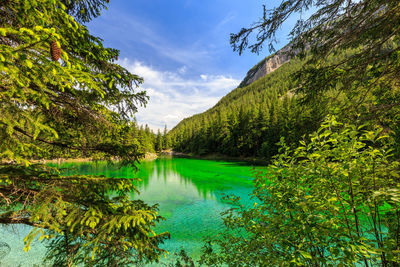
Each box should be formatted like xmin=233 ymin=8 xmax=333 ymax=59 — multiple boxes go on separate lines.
xmin=0 ymin=0 xmax=168 ymax=266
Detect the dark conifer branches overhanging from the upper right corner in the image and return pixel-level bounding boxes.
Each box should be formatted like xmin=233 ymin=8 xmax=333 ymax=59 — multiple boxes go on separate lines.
xmin=231 ymin=0 xmax=400 ymax=158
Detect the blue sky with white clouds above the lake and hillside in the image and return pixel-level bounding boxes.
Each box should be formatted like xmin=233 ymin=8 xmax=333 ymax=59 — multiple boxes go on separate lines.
xmin=87 ymin=0 xmax=293 ymax=130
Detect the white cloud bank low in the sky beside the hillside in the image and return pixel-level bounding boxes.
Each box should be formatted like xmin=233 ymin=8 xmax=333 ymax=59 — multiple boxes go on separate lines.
xmin=120 ymin=59 xmax=240 ymax=133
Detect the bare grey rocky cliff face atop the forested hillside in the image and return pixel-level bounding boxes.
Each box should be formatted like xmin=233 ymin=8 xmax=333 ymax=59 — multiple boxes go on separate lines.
xmin=239 ymin=45 xmax=290 ymax=87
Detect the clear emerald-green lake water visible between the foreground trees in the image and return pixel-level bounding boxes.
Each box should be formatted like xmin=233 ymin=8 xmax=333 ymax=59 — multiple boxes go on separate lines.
xmin=0 ymin=158 xmax=253 ymax=267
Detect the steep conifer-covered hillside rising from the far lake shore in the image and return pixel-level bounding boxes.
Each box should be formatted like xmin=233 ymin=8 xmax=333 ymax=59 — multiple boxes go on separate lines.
xmin=170 ymin=54 xmax=325 ymax=158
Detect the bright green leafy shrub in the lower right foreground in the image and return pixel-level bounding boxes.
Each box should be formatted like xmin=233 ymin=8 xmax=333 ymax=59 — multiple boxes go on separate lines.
xmin=201 ymin=116 xmax=400 ymax=266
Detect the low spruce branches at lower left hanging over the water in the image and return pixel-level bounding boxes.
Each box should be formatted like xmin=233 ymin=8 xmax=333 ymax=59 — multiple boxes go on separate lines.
xmin=0 ymin=165 xmax=167 ymax=266
